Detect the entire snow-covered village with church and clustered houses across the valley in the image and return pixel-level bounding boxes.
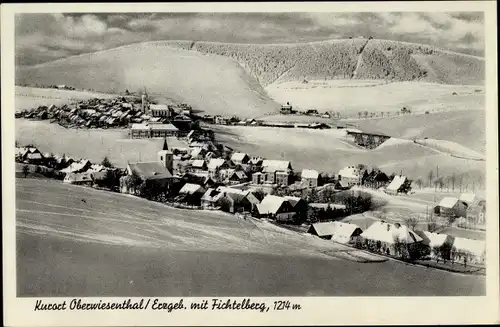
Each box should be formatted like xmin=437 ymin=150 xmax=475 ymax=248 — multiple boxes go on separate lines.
xmin=16 ymin=92 xmax=485 ymax=272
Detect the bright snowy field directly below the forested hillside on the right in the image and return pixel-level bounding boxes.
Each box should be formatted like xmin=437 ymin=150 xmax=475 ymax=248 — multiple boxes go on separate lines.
xmin=266 ymin=80 xmax=485 ymax=117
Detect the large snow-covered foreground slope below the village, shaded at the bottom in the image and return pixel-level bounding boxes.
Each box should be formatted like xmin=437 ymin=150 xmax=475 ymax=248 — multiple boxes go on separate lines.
xmin=16 ymin=178 xmax=485 ymax=297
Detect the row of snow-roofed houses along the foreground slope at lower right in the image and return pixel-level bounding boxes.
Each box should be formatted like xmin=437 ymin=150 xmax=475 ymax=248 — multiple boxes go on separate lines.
xmin=307 ymin=221 xmax=485 ymax=265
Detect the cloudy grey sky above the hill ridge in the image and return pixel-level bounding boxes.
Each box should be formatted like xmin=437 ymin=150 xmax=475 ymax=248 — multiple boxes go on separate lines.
xmin=15 ymin=12 xmax=484 ymax=65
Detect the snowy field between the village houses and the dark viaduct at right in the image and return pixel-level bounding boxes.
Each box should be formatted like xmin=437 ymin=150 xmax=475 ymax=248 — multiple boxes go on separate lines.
xmin=215 ymin=126 xmax=486 ymax=181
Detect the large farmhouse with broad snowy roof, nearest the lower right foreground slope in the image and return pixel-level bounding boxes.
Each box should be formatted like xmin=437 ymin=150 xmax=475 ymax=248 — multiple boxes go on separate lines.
xmin=360 ymin=221 xmax=423 ymax=258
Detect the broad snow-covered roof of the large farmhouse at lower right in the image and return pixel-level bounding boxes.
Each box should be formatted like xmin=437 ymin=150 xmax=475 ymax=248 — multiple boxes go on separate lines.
xmin=361 ymin=221 xmax=423 ymax=244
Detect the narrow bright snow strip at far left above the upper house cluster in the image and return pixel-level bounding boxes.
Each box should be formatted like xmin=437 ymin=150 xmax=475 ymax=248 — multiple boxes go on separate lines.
xmin=15 ymin=86 xmax=116 ymax=111
